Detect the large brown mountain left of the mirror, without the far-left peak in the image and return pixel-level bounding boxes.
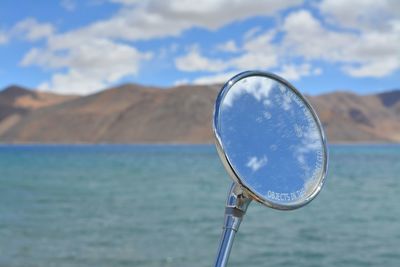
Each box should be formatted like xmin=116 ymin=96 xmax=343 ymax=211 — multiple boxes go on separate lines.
xmin=0 ymin=85 xmax=217 ymax=143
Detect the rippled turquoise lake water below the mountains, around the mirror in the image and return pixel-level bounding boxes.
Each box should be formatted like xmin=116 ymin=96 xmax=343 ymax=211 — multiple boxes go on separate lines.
xmin=0 ymin=145 xmax=400 ymax=267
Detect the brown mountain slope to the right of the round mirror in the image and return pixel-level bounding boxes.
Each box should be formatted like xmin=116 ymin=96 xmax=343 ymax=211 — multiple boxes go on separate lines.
xmin=310 ymin=91 xmax=400 ymax=142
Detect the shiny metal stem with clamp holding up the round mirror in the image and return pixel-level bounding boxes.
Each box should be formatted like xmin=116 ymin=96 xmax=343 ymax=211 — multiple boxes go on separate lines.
xmin=215 ymin=183 xmax=251 ymax=267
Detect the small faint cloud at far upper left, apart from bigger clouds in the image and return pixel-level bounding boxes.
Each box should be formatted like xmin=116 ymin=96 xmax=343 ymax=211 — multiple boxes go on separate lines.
xmin=11 ymin=18 xmax=54 ymax=41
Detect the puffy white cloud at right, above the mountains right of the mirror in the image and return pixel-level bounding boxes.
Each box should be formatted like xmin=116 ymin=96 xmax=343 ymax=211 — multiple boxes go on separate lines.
xmin=282 ymin=10 xmax=400 ymax=77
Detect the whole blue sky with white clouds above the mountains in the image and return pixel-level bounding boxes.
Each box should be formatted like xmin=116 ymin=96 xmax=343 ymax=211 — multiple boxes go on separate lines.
xmin=0 ymin=0 xmax=400 ymax=94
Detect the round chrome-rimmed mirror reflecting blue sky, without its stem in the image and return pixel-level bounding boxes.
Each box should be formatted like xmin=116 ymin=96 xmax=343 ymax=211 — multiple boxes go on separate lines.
xmin=214 ymin=71 xmax=327 ymax=210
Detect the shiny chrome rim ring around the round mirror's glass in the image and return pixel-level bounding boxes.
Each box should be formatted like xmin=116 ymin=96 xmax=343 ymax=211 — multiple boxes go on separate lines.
xmin=213 ymin=71 xmax=328 ymax=210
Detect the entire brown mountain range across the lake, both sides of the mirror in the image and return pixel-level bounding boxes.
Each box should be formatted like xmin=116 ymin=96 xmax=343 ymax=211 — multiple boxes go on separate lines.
xmin=0 ymin=84 xmax=400 ymax=143
